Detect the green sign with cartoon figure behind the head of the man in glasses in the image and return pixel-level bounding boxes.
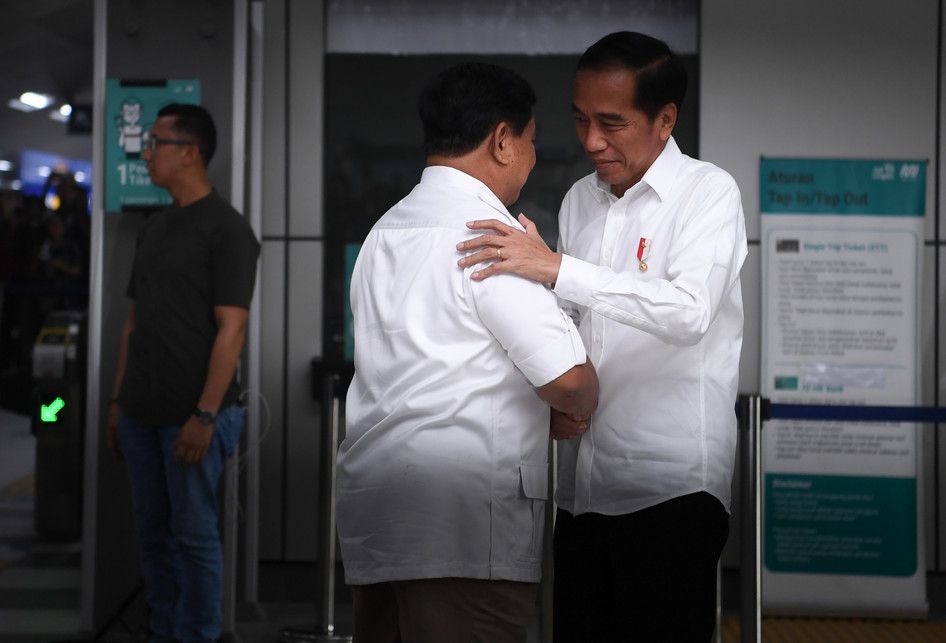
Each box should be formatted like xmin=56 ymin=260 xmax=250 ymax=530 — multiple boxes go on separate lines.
xmin=105 ymin=78 xmax=200 ymax=212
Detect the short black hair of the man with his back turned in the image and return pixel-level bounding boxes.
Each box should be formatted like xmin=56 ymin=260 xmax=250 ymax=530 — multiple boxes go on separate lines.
xmin=417 ymin=62 xmax=535 ymax=157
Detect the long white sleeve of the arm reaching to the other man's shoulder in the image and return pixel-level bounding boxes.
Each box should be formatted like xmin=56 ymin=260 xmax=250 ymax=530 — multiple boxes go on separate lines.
xmin=555 ymin=175 xmax=747 ymax=345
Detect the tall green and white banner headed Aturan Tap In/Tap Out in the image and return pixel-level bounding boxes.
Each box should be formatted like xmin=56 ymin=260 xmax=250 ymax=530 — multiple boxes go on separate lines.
xmin=760 ymin=158 xmax=927 ymax=616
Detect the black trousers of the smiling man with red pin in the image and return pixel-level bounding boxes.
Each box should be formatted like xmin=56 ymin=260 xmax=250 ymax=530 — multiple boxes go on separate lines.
xmin=553 ymin=491 xmax=729 ymax=643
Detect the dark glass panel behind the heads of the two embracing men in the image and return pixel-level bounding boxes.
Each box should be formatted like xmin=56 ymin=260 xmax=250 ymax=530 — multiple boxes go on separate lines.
xmin=325 ymin=54 xmax=699 ymax=358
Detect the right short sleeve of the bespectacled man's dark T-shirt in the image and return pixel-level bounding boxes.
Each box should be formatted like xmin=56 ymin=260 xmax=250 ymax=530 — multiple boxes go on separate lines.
xmin=212 ymin=215 xmax=260 ymax=308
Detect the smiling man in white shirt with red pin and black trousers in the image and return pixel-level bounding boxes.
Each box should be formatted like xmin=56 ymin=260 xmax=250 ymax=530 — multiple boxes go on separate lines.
xmin=458 ymin=32 xmax=747 ymax=643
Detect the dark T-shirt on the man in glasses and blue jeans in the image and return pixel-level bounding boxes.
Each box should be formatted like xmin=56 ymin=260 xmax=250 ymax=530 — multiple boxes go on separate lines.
xmin=121 ymin=192 xmax=260 ymax=426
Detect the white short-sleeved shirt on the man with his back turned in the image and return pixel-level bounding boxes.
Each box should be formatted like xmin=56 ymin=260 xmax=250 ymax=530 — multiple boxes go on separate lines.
xmin=336 ymin=166 xmax=586 ymax=585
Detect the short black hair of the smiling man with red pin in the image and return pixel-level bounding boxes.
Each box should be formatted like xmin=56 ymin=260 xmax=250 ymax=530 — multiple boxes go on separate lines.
xmin=576 ymin=31 xmax=687 ymax=120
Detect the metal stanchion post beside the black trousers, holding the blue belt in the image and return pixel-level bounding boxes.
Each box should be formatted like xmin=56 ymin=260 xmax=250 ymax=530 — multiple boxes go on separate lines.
xmin=739 ymin=395 xmax=762 ymax=643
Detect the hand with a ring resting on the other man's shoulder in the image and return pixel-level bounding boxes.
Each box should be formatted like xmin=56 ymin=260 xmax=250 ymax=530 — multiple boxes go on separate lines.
xmin=457 ymin=214 xmax=562 ymax=284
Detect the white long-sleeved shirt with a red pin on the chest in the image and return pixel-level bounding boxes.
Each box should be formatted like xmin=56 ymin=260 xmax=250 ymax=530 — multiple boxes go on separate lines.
xmin=555 ymin=138 xmax=747 ymax=515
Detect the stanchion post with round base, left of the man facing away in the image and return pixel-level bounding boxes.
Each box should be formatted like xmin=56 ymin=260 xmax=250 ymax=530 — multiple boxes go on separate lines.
xmin=281 ymin=373 xmax=351 ymax=643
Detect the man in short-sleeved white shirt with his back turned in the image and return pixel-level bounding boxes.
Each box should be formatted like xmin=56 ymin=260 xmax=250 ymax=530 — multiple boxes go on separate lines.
xmin=336 ymin=63 xmax=598 ymax=643
